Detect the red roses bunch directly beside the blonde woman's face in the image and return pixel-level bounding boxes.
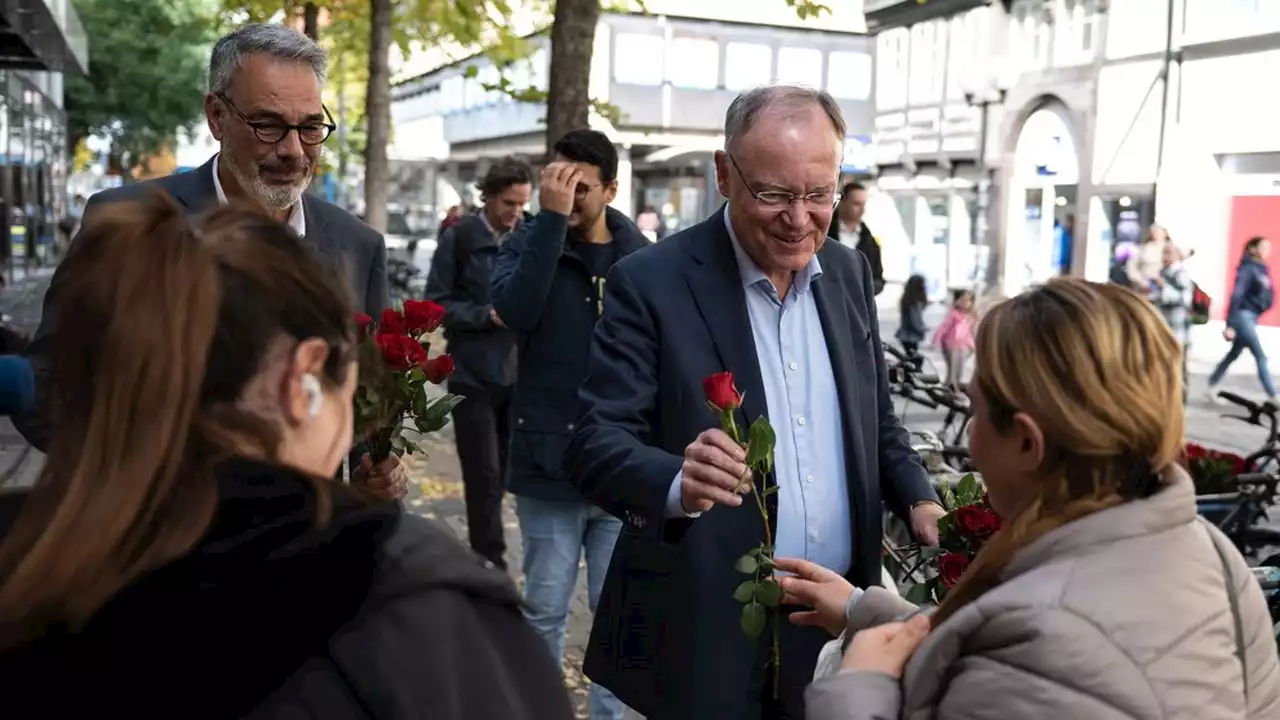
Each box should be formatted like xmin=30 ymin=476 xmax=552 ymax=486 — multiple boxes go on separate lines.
xmin=904 ymin=473 xmax=1001 ymax=605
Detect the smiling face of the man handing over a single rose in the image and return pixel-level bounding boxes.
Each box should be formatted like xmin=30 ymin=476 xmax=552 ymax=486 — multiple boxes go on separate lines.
xmin=716 ymin=105 xmax=841 ymax=295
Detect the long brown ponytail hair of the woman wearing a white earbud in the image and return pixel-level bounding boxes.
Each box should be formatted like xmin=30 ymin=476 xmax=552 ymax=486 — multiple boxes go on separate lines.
xmin=0 ymin=192 xmax=355 ymax=635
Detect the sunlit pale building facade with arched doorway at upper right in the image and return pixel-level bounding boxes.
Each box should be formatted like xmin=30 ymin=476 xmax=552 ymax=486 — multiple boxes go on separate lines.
xmin=867 ymin=0 xmax=1280 ymax=325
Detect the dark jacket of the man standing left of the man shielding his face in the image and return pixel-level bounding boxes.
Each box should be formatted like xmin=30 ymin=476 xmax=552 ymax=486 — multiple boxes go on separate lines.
xmin=426 ymin=214 xmax=516 ymax=395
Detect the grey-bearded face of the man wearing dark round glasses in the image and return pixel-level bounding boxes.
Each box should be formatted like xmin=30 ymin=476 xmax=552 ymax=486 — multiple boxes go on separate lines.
xmin=205 ymin=54 xmax=328 ymax=211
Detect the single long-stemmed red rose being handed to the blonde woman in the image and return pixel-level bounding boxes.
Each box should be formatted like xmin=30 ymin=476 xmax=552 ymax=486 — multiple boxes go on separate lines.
xmin=703 ymin=373 xmax=782 ymax=696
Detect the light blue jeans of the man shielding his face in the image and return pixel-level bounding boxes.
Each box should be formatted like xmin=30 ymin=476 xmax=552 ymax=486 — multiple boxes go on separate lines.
xmin=516 ymin=496 xmax=625 ymax=720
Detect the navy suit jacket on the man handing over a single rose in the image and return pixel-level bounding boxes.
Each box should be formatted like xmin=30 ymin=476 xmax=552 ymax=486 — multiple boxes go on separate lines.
xmin=566 ymin=207 xmax=936 ymax=720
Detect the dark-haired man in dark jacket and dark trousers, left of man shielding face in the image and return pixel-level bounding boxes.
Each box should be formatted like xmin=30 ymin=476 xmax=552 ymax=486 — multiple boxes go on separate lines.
xmin=426 ymin=158 xmax=534 ymax=569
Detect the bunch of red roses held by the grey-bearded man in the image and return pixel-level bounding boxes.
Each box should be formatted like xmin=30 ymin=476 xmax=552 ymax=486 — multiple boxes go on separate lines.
xmin=356 ymin=300 xmax=462 ymax=464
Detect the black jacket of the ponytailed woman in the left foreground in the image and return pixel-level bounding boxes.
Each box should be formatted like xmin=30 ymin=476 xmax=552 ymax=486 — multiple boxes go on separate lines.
xmin=0 ymin=460 xmax=572 ymax=720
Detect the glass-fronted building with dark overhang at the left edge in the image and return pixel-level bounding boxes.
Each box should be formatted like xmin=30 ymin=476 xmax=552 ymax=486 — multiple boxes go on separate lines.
xmin=0 ymin=0 xmax=88 ymax=268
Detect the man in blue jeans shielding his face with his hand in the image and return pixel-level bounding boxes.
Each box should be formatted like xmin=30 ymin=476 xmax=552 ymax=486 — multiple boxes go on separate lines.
xmin=493 ymin=129 xmax=649 ymax=720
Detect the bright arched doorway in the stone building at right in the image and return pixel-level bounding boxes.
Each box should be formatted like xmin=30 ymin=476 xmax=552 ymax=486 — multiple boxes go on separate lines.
xmin=1004 ymin=101 xmax=1080 ymax=293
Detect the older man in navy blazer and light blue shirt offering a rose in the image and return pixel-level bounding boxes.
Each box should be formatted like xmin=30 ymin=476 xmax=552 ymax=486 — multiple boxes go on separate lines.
xmin=566 ymin=87 xmax=942 ymax=720
